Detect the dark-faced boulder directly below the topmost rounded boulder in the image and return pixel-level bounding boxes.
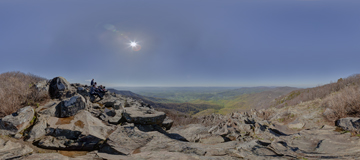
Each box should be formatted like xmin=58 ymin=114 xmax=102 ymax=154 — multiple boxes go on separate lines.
xmin=56 ymin=94 xmax=87 ymax=118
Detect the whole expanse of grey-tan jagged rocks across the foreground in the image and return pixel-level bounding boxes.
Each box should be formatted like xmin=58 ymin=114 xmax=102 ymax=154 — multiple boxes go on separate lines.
xmin=0 ymin=77 xmax=360 ymax=160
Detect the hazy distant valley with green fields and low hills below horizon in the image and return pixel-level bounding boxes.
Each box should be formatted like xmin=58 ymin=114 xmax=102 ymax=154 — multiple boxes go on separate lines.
xmin=109 ymin=87 xmax=299 ymax=116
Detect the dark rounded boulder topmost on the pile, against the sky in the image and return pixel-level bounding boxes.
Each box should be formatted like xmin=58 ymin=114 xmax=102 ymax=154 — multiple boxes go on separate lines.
xmin=49 ymin=77 xmax=76 ymax=98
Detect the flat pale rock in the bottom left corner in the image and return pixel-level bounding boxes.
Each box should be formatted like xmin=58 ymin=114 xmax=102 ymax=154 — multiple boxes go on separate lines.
xmin=0 ymin=138 xmax=33 ymax=159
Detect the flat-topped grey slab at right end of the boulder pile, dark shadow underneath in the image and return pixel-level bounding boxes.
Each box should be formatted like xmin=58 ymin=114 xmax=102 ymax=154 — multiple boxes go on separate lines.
xmin=123 ymin=107 xmax=166 ymax=125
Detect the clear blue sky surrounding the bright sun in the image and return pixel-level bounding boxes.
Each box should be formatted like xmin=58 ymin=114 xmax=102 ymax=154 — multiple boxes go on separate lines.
xmin=0 ymin=0 xmax=360 ymax=87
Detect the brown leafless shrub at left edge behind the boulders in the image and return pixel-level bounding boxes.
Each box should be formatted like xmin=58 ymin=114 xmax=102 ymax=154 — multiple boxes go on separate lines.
xmin=0 ymin=72 xmax=49 ymax=118
